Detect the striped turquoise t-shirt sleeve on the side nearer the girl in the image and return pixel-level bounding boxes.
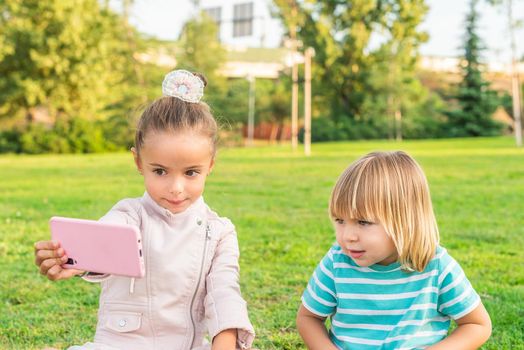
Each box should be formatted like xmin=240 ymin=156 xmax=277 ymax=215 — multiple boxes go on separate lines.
xmin=302 ymin=250 xmax=337 ymax=317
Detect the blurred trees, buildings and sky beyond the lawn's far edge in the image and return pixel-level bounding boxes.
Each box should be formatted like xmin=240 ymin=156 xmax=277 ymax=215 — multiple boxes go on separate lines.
xmin=0 ymin=0 xmax=524 ymax=153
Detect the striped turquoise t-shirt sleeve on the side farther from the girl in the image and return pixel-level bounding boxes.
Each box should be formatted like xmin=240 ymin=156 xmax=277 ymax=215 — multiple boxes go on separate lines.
xmin=438 ymin=252 xmax=480 ymax=320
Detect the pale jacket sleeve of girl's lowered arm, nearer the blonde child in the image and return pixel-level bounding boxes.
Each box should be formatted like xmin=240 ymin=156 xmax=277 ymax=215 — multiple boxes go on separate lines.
xmin=204 ymin=222 xmax=255 ymax=349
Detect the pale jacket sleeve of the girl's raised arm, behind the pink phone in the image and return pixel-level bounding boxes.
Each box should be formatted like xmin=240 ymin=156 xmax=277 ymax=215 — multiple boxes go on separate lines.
xmin=82 ymin=199 xmax=140 ymax=283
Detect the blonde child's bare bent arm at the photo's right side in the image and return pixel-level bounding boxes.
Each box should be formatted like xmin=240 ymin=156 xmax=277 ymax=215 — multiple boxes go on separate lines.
xmin=427 ymin=302 xmax=491 ymax=350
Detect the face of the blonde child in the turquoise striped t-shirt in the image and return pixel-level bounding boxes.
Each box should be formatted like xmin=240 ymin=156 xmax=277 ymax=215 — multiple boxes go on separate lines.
xmin=334 ymin=219 xmax=398 ymax=267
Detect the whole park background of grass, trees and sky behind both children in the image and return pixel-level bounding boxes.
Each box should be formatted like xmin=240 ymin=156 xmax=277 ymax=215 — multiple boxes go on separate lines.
xmin=0 ymin=0 xmax=524 ymax=350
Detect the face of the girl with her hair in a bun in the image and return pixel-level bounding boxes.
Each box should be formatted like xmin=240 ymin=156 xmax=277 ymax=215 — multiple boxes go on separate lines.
xmin=132 ymin=131 xmax=214 ymax=214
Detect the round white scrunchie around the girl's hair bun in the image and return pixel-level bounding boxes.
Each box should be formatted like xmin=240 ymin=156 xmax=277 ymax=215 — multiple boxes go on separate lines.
xmin=162 ymin=69 xmax=204 ymax=103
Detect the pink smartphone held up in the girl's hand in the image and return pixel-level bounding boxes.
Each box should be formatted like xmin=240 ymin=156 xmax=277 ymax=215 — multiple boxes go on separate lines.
xmin=49 ymin=216 xmax=145 ymax=277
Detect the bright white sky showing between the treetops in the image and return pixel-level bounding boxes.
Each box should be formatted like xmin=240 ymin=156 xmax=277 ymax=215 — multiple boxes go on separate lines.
xmin=122 ymin=0 xmax=524 ymax=63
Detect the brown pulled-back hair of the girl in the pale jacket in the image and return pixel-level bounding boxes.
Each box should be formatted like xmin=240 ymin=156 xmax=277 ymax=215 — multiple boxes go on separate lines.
xmin=135 ymin=73 xmax=218 ymax=153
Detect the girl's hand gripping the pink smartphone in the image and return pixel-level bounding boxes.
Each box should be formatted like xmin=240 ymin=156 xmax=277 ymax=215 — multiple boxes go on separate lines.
xmin=35 ymin=241 xmax=84 ymax=281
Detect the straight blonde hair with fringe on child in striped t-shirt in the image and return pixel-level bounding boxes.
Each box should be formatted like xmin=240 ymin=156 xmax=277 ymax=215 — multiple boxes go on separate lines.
xmin=329 ymin=151 xmax=439 ymax=271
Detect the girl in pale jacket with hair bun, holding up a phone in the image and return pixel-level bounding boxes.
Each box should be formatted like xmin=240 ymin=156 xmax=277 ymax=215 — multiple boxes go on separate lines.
xmin=35 ymin=70 xmax=254 ymax=350
